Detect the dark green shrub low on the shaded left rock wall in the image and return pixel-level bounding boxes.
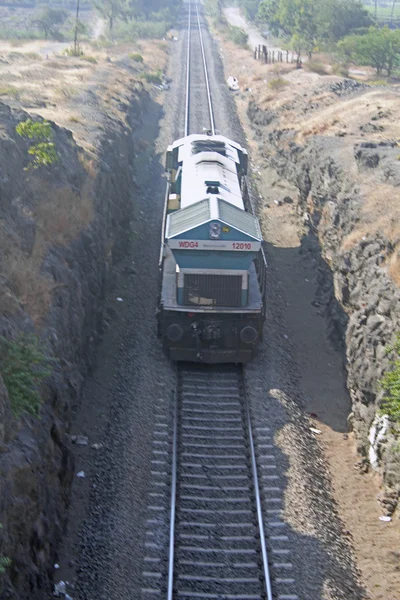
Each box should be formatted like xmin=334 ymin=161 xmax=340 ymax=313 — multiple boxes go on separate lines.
xmin=0 ymin=335 xmax=51 ymax=417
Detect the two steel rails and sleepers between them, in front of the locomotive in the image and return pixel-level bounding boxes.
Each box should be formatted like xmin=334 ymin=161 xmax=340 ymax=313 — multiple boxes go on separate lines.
xmin=168 ymin=366 xmax=272 ymax=600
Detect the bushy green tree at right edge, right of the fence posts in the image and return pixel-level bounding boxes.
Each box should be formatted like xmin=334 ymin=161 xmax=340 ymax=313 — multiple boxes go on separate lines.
xmin=338 ymin=27 xmax=400 ymax=76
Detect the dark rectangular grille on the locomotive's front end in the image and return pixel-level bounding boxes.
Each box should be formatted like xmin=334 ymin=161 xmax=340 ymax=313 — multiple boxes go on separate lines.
xmin=183 ymin=273 xmax=242 ymax=306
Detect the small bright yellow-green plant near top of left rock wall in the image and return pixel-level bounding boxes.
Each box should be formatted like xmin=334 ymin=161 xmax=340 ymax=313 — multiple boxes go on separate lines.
xmin=15 ymin=119 xmax=58 ymax=171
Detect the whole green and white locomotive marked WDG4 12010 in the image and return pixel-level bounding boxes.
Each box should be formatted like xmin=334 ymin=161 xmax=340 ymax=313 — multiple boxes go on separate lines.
xmin=158 ymin=135 xmax=266 ymax=363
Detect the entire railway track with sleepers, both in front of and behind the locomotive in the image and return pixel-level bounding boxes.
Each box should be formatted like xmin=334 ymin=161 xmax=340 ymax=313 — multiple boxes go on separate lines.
xmin=142 ymin=2 xmax=299 ymax=600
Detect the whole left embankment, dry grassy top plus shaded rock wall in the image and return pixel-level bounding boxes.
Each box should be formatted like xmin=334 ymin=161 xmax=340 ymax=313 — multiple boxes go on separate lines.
xmin=0 ymin=39 xmax=165 ymax=600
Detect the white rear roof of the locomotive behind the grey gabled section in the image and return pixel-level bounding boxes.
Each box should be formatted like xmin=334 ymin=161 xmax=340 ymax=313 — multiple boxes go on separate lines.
xmin=173 ymin=135 xmax=244 ymax=210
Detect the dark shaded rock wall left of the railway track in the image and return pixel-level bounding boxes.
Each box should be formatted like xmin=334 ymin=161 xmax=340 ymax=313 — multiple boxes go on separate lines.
xmin=0 ymin=88 xmax=148 ymax=600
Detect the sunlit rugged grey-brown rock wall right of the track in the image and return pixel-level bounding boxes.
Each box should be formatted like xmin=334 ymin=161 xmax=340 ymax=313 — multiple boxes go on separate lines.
xmin=248 ymin=98 xmax=400 ymax=488
